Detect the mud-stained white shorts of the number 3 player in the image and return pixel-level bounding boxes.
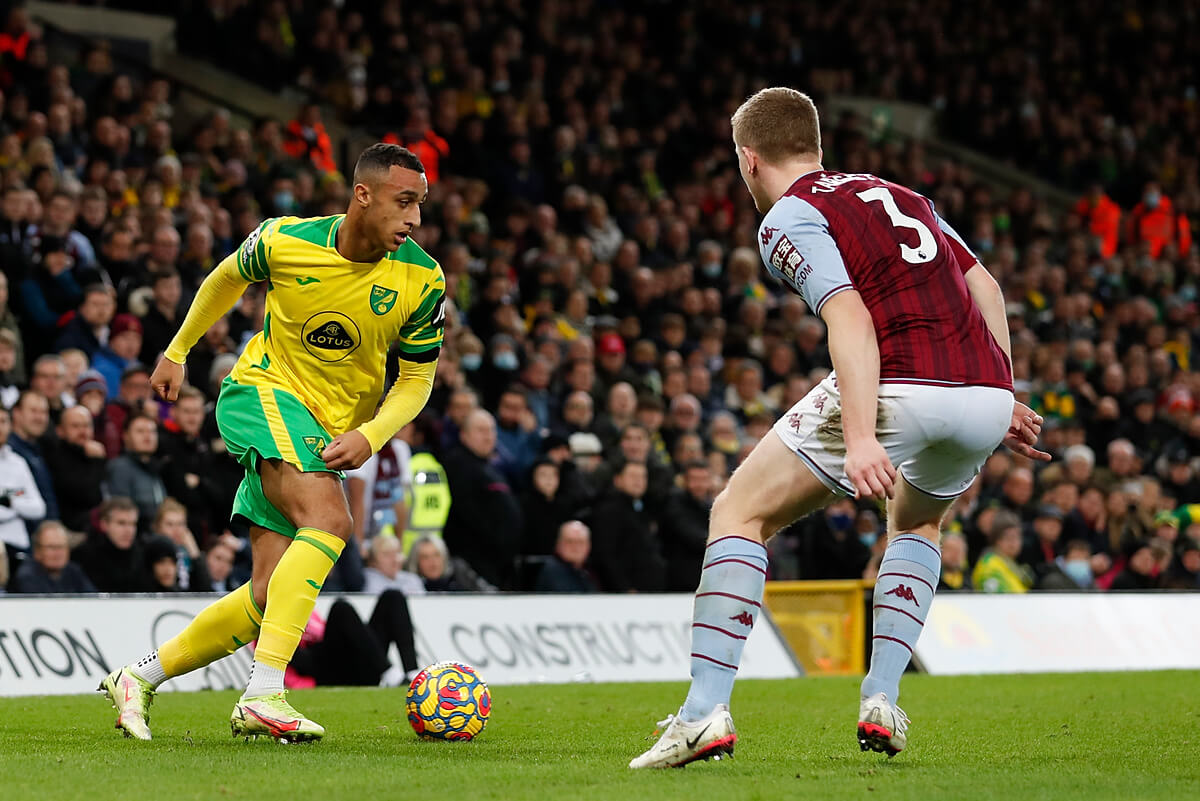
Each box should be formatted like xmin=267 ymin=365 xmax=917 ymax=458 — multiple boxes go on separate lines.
xmin=775 ymin=373 xmax=1013 ymax=500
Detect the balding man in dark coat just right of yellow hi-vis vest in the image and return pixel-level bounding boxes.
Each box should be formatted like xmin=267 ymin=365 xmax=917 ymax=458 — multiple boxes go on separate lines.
xmin=443 ymin=409 xmax=523 ymax=588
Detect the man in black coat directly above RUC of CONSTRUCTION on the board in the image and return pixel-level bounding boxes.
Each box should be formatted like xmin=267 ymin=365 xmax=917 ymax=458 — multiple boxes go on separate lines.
xmin=588 ymin=462 xmax=666 ymax=592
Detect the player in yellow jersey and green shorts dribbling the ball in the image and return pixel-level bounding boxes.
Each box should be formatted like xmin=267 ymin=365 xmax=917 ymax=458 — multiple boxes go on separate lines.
xmin=100 ymin=144 xmax=445 ymax=742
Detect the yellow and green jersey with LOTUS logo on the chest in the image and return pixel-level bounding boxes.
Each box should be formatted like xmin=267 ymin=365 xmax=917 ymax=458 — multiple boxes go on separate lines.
xmin=228 ymin=215 xmax=445 ymax=436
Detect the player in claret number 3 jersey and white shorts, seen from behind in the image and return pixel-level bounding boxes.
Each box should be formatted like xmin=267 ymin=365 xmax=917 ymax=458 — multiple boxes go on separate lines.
xmin=630 ymin=88 xmax=1050 ymax=767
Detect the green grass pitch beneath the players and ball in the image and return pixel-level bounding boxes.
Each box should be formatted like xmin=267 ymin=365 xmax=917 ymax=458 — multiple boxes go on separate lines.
xmin=0 ymin=671 xmax=1200 ymax=801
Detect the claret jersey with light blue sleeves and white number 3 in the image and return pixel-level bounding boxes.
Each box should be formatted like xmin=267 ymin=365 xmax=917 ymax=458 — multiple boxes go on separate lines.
xmin=758 ymin=170 xmax=1013 ymax=390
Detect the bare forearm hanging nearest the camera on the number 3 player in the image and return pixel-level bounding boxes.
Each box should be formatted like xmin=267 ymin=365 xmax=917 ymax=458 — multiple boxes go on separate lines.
xmin=829 ymin=307 xmax=880 ymax=446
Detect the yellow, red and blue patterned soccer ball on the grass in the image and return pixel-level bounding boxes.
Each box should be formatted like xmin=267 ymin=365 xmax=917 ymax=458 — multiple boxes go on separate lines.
xmin=407 ymin=662 xmax=492 ymax=740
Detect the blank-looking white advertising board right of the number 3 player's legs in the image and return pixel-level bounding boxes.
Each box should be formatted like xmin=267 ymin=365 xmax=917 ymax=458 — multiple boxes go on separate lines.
xmin=916 ymin=592 xmax=1200 ymax=674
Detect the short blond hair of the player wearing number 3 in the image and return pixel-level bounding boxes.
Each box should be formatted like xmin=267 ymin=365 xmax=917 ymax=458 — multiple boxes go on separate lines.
xmin=731 ymin=86 xmax=821 ymax=163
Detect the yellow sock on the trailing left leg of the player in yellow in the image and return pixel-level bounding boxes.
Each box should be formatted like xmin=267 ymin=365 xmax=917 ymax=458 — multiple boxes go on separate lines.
xmin=158 ymin=582 xmax=263 ymax=679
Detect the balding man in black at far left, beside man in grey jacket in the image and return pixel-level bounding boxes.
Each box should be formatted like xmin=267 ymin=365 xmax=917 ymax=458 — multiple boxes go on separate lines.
xmin=46 ymin=404 xmax=107 ymax=532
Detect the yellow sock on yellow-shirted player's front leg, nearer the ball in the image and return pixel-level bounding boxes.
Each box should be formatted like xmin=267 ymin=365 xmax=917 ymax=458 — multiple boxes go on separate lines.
xmin=254 ymin=528 xmax=346 ymax=670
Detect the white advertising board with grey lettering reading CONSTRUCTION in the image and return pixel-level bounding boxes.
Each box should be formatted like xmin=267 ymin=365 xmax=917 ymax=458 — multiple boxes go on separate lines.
xmin=0 ymin=594 xmax=800 ymax=695
